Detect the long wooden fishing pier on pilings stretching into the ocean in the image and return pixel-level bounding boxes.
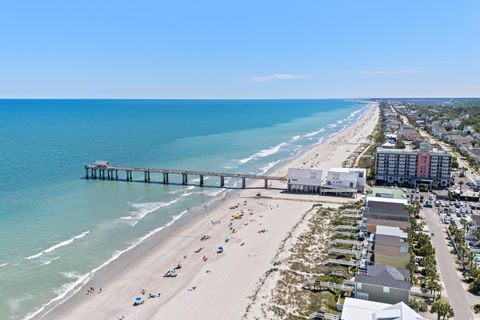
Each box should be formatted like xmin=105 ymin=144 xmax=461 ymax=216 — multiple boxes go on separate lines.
xmin=85 ymin=161 xmax=286 ymax=189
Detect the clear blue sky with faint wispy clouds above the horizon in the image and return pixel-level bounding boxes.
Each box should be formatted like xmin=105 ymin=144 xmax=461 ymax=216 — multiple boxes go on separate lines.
xmin=0 ymin=0 xmax=480 ymax=99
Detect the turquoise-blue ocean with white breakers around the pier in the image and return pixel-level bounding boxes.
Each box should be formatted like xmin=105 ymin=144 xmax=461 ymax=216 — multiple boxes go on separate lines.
xmin=0 ymin=100 xmax=368 ymax=319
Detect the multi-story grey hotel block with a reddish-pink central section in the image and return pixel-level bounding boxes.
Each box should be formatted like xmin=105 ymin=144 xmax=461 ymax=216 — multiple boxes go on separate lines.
xmin=375 ymin=143 xmax=452 ymax=188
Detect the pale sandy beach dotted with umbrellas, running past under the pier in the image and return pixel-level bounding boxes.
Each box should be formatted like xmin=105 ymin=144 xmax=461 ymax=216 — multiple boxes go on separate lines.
xmin=39 ymin=106 xmax=378 ymax=320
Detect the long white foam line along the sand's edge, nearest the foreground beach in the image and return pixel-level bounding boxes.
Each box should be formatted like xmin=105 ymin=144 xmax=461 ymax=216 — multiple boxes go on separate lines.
xmin=24 ymin=210 xmax=188 ymax=320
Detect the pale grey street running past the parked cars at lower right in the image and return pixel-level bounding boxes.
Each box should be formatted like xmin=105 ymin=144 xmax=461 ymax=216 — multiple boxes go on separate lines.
xmin=422 ymin=208 xmax=474 ymax=319
